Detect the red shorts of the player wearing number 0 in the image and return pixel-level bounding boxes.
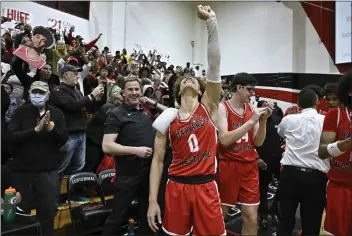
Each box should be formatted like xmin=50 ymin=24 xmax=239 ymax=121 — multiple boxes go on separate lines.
xmin=163 ymin=180 xmax=226 ymax=235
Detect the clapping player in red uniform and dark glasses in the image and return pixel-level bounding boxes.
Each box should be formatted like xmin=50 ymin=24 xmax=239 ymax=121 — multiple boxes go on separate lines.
xmin=218 ymin=73 xmax=273 ymax=235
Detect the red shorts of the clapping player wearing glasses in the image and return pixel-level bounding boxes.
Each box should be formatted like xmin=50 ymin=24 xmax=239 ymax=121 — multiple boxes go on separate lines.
xmin=217 ymin=160 xmax=260 ymax=206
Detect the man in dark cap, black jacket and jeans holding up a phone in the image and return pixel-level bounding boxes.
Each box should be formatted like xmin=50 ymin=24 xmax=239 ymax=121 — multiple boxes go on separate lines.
xmin=51 ymin=64 xmax=104 ymax=193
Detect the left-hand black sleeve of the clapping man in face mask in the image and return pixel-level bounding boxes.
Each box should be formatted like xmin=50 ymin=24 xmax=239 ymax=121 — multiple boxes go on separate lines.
xmin=8 ymin=107 xmax=36 ymax=143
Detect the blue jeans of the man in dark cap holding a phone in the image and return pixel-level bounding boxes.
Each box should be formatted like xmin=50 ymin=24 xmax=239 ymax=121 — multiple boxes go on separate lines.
xmin=58 ymin=132 xmax=86 ymax=194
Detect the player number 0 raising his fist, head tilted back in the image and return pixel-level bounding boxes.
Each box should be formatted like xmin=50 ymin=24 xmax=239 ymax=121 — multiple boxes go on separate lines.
xmin=148 ymin=6 xmax=226 ymax=235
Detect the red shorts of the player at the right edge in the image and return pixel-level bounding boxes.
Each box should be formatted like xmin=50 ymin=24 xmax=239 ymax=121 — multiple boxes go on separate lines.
xmin=324 ymin=181 xmax=352 ymax=236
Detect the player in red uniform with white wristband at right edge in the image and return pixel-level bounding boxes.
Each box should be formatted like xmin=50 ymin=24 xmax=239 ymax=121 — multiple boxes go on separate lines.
xmin=318 ymin=73 xmax=352 ymax=236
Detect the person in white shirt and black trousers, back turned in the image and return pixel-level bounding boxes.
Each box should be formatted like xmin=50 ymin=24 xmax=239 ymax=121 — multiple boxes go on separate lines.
xmin=277 ymin=89 xmax=330 ymax=235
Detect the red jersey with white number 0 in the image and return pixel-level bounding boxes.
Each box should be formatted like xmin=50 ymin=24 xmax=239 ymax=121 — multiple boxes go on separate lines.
xmin=169 ymin=103 xmax=218 ymax=176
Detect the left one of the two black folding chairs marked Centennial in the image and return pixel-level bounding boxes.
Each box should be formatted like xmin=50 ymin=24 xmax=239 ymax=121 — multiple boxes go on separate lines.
xmin=67 ymin=172 xmax=111 ymax=235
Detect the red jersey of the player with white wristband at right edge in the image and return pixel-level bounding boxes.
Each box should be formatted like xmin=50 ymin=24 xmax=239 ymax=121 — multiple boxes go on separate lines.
xmin=323 ymin=107 xmax=352 ymax=188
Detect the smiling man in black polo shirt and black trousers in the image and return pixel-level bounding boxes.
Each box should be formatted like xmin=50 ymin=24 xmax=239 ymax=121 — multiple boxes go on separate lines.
xmin=102 ymin=78 xmax=166 ymax=235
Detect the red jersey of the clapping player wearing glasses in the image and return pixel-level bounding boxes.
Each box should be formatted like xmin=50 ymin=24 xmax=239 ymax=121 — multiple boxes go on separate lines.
xmin=219 ymin=101 xmax=258 ymax=162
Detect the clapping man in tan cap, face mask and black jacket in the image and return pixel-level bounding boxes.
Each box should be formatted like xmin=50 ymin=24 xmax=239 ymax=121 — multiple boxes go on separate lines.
xmin=8 ymin=81 xmax=68 ymax=235
